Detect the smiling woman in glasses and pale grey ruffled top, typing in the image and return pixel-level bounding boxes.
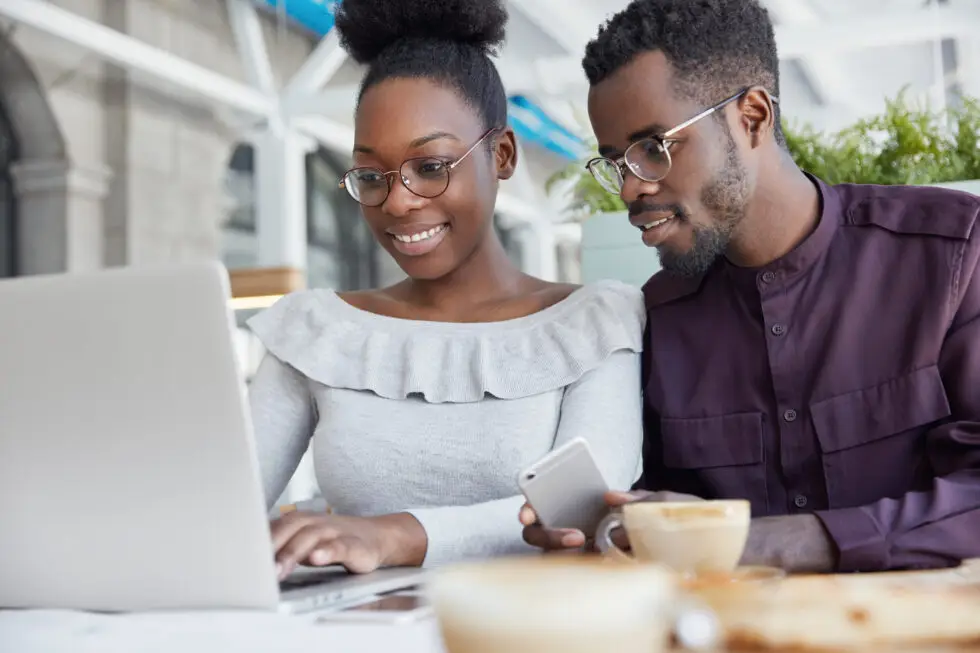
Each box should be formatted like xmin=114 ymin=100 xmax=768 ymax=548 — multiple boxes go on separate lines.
xmin=249 ymin=0 xmax=644 ymax=576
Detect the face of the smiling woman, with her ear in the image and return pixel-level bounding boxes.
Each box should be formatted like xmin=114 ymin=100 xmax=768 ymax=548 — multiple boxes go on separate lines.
xmin=354 ymin=78 xmax=517 ymax=279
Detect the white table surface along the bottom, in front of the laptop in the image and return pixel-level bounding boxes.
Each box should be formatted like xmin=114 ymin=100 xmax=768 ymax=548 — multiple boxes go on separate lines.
xmin=0 ymin=610 xmax=443 ymax=653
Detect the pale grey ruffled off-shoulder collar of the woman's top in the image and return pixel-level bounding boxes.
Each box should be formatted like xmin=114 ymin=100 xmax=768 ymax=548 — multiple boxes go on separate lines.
xmin=248 ymin=282 xmax=646 ymax=403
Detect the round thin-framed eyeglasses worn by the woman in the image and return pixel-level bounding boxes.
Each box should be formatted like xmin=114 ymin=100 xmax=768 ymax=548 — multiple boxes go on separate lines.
xmin=340 ymin=127 xmax=500 ymax=207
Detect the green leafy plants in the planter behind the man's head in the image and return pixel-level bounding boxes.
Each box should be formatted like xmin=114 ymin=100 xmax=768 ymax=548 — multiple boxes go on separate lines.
xmin=546 ymin=90 xmax=980 ymax=219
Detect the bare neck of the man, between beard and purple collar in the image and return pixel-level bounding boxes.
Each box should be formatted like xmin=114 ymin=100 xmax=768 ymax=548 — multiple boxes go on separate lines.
xmin=726 ymin=153 xmax=820 ymax=268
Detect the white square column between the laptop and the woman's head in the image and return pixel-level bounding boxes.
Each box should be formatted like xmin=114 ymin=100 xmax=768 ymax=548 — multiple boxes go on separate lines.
xmin=254 ymin=129 xmax=312 ymax=270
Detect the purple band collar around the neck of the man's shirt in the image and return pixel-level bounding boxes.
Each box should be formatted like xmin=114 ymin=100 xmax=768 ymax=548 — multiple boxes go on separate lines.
xmin=643 ymin=173 xmax=841 ymax=309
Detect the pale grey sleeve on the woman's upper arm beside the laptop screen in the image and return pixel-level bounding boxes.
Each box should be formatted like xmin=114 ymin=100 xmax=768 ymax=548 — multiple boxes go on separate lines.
xmin=248 ymin=354 xmax=316 ymax=509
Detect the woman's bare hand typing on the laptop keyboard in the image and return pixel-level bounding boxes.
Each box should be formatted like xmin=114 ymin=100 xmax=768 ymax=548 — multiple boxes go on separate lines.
xmin=271 ymin=512 xmax=428 ymax=580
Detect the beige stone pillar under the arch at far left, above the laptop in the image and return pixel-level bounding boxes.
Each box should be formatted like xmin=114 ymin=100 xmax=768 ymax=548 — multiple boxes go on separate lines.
xmin=10 ymin=159 xmax=112 ymax=274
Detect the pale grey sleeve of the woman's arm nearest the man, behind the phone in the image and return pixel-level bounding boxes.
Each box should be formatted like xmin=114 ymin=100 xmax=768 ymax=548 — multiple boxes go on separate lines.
xmin=406 ymin=350 xmax=642 ymax=567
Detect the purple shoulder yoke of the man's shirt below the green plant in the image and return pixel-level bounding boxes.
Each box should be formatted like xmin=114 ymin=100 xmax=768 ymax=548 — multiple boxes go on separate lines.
xmin=834 ymin=184 xmax=980 ymax=240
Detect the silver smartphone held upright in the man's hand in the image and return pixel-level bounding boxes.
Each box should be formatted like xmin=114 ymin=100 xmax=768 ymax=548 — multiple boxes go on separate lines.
xmin=517 ymin=438 xmax=609 ymax=538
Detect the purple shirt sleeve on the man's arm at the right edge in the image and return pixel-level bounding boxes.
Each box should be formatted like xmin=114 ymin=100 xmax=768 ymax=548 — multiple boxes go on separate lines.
xmin=816 ymin=241 xmax=980 ymax=571
